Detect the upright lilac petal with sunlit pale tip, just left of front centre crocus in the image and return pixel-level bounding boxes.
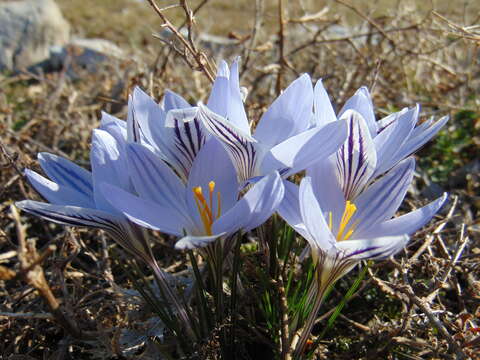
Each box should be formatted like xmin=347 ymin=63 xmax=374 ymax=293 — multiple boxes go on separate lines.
xmin=90 ymin=129 xmax=130 ymax=212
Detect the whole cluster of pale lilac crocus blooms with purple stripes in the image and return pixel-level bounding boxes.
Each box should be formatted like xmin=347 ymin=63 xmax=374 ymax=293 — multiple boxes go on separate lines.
xmin=16 ymin=58 xmax=447 ymax=355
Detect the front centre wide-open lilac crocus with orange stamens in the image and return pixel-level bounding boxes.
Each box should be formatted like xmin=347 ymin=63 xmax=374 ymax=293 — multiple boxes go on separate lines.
xmin=102 ymin=138 xmax=284 ymax=249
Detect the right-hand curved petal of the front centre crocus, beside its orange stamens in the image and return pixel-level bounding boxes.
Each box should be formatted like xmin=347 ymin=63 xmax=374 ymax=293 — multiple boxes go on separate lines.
xmin=213 ymin=172 xmax=284 ymax=234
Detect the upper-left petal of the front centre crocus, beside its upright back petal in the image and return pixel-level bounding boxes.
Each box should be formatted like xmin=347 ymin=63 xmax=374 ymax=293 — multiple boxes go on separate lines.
xmin=127 ymin=143 xmax=186 ymax=214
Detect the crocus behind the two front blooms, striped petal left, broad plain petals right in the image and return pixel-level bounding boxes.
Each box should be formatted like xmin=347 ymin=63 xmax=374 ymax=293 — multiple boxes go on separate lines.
xmin=199 ymin=63 xmax=346 ymax=183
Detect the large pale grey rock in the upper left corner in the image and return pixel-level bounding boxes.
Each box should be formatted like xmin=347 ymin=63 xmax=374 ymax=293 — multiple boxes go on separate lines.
xmin=0 ymin=0 xmax=70 ymax=70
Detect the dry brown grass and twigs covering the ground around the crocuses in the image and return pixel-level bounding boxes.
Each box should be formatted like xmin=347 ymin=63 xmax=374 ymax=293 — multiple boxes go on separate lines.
xmin=0 ymin=0 xmax=480 ymax=359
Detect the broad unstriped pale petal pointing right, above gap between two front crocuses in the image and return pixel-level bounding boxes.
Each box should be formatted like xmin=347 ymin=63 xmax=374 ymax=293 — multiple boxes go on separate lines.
xmin=262 ymin=120 xmax=347 ymax=177
